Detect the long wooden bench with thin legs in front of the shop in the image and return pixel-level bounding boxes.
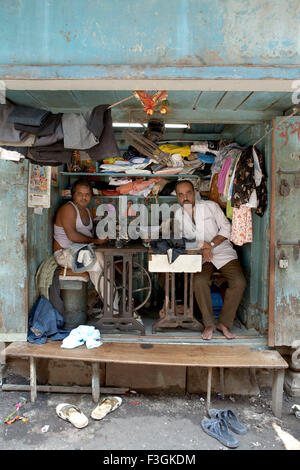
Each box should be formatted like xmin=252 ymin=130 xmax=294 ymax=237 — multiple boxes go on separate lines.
xmin=2 ymin=341 xmax=288 ymax=418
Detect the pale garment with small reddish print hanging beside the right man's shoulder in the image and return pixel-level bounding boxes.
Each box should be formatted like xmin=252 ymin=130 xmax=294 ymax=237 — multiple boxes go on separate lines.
xmin=230 ymin=205 xmax=252 ymax=246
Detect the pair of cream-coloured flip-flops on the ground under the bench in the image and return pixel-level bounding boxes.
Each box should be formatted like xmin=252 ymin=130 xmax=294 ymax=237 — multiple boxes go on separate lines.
xmin=56 ymin=397 xmax=122 ymax=429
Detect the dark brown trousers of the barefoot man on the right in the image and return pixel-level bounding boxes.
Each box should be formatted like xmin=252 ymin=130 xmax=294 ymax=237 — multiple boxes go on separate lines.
xmin=193 ymin=259 xmax=246 ymax=329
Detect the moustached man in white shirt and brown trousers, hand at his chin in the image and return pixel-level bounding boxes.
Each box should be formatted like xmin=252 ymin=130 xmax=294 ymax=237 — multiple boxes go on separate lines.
xmin=175 ymin=180 xmax=246 ymax=340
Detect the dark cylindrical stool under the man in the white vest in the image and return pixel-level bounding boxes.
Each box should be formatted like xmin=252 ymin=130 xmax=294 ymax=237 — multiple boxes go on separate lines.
xmin=59 ymin=268 xmax=89 ymax=329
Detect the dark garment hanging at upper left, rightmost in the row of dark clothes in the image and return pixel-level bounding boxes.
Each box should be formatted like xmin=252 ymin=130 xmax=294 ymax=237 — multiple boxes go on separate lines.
xmin=87 ymin=104 xmax=120 ymax=161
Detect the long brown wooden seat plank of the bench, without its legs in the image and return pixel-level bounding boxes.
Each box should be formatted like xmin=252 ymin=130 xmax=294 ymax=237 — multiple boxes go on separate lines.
xmin=5 ymin=341 xmax=288 ymax=369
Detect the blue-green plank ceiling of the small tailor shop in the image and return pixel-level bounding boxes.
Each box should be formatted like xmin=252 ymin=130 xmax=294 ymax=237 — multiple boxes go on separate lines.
xmin=6 ymin=90 xmax=295 ymax=139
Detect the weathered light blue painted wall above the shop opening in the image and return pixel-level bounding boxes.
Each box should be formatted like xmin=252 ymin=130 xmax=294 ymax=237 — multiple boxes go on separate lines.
xmin=0 ymin=0 xmax=300 ymax=67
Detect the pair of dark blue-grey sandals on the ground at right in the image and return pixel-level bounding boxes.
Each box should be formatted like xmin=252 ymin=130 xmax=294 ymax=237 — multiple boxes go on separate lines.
xmin=201 ymin=408 xmax=247 ymax=449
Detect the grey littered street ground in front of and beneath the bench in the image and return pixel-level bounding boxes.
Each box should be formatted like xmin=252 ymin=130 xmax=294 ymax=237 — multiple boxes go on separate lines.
xmin=0 ymin=370 xmax=300 ymax=454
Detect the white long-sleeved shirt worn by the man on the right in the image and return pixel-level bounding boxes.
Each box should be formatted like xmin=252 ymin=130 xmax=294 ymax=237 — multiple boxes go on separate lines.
xmin=175 ymin=198 xmax=237 ymax=269
